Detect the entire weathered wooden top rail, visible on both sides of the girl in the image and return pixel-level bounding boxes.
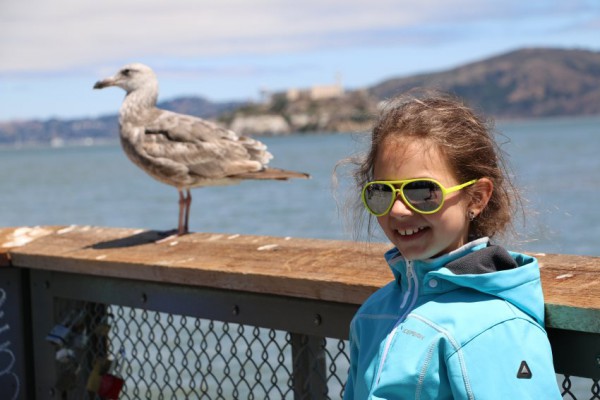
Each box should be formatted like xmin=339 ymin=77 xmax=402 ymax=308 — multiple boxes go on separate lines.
xmin=0 ymin=226 xmax=600 ymax=333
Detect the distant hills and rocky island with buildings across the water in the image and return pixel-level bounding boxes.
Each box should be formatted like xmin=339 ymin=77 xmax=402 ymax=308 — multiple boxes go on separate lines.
xmin=0 ymin=48 xmax=600 ymax=146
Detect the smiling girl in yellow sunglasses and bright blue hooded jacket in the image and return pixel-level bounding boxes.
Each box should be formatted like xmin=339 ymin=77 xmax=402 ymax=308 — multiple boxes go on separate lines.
xmin=344 ymin=93 xmax=561 ymax=400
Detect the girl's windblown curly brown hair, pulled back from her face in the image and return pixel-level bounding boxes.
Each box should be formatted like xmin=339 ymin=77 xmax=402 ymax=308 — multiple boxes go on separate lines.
xmin=336 ymin=89 xmax=522 ymax=239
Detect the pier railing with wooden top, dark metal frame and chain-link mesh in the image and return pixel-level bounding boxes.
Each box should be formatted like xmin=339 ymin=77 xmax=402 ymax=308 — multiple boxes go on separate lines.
xmin=0 ymin=226 xmax=600 ymax=399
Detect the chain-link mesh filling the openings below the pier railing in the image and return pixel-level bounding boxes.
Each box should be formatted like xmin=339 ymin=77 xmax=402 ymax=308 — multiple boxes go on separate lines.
xmin=47 ymin=299 xmax=600 ymax=400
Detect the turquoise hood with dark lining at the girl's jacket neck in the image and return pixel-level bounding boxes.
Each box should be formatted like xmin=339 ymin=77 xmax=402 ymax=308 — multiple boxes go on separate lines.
xmin=385 ymin=238 xmax=544 ymax=326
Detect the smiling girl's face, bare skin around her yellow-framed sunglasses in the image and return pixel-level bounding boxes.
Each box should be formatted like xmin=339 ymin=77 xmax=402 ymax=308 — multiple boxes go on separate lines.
xmin=373 ymin=138 xmax=469 ymax=260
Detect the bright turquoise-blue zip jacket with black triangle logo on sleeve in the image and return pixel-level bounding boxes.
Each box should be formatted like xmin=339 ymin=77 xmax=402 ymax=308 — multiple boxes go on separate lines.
xmin=344 ymin=238 xmax=562 ymax=400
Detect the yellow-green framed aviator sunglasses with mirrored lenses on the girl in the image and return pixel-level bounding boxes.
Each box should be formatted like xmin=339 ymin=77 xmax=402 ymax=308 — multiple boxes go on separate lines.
xmin=362 ymin=178 xmax=477 ymax=217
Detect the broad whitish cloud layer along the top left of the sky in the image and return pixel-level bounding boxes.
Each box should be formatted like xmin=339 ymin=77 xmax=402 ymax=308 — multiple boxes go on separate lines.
xmin=0 ymin=0 xmax=580 ymax=73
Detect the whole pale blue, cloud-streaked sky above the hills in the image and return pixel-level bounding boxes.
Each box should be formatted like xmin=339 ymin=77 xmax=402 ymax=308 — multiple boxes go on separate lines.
xmin=0 ymin=0 xmax=600 ymax=121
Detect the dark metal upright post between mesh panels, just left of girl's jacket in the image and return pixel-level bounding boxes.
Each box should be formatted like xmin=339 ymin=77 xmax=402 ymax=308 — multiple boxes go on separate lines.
xmin=290 ymin=333 xmax=328 ymax=400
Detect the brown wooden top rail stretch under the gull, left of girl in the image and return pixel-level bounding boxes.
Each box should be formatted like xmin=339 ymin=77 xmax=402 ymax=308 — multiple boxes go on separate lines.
xmin=2 ymin=227 xmax=392 ymax=304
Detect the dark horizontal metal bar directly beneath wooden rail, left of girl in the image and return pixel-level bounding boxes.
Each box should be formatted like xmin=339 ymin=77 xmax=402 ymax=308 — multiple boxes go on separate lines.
xmin=31 ymin=270 xmax=358 ymax=339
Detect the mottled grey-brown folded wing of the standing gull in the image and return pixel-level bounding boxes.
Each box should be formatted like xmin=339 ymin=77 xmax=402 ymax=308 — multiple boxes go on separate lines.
xmin=142 ymin=109 xmax=272 ymax=179
